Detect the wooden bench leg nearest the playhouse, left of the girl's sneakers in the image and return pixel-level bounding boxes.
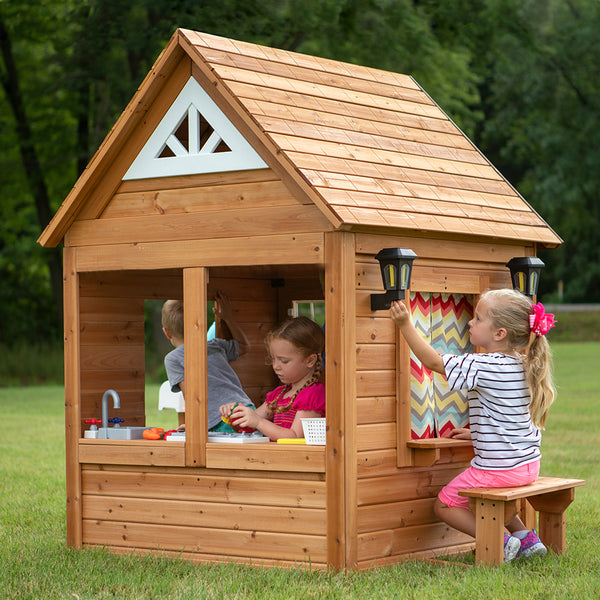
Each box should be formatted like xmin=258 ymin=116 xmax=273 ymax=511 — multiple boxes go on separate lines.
xmin=471 ymin=498 xmax=516 ymax=565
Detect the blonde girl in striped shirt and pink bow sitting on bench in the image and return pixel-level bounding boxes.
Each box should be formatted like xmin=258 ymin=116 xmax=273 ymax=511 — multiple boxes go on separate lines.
xmin=390 ymin=289 xmax=555 ymax=562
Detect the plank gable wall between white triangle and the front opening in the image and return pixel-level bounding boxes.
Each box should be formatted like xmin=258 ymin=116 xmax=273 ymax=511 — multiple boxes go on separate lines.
xmin=67 ymin=169 xmax=331 ymax=271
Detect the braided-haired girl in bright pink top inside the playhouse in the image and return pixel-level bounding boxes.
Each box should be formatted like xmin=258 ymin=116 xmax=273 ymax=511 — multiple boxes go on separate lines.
xmin=220 ymin=317 xmax=325 ymax=441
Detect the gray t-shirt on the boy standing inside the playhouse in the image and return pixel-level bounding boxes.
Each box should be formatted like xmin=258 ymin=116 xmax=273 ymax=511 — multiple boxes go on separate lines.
xmin=165 ymin=338 xmax=254 ymax=429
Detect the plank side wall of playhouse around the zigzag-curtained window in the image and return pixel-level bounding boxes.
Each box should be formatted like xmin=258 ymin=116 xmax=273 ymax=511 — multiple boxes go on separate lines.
xmin=355 ymin=234 xmax=530 ymax=568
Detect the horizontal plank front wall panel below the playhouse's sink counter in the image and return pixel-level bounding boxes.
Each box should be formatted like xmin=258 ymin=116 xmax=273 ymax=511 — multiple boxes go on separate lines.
xmin=82 ymin=465 xmax=326 ymax=568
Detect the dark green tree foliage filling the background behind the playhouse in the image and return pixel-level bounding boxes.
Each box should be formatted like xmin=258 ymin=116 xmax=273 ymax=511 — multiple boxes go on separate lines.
xmin=0 ymin=0 xmax=600 ymax=343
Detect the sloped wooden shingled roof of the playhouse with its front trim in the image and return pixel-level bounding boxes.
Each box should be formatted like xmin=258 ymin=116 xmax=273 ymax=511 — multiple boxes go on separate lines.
xmin=39 ymin=29 xmax=561 ymax=247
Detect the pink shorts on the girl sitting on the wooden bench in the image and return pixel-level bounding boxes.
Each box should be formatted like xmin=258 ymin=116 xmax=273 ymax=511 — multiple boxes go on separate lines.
xmin=438 ymin=460 xmax=540 ymax=508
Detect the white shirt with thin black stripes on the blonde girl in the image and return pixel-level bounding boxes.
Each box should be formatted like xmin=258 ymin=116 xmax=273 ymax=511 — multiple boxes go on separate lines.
xmin=442 ymin=353 xmax=542 ymax=471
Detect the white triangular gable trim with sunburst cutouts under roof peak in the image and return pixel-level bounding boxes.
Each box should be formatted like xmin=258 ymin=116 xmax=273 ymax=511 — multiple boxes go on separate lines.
xmin=123 ymin=77 xmax=268 ymax=179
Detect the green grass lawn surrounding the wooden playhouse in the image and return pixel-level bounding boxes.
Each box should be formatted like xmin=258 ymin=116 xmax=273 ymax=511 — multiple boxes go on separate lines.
xmin=0 ymin=343 xmax=600 ymax=600
